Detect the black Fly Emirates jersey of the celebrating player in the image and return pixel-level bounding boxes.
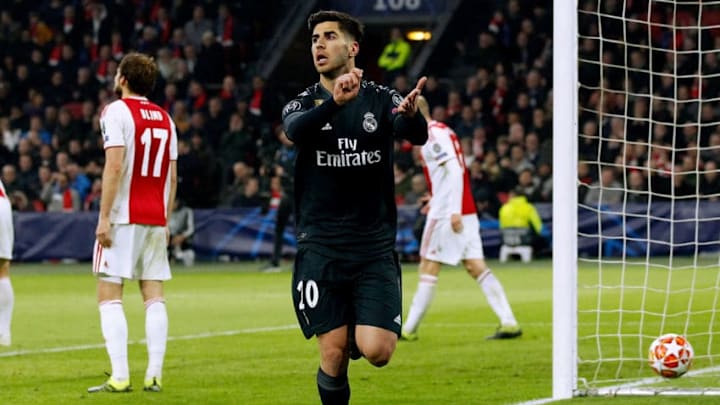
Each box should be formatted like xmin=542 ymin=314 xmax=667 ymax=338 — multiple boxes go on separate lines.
xmin=283 ymin=81 xmax=427 ymax=258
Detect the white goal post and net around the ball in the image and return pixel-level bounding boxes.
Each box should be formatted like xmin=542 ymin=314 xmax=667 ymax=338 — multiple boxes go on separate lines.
xmin=553 ymin=0 xmax=720 ymax=398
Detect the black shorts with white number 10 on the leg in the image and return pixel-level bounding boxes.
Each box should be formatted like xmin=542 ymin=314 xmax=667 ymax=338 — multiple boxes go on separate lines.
xmin=292 ymin=247 xmax=402 ymax=339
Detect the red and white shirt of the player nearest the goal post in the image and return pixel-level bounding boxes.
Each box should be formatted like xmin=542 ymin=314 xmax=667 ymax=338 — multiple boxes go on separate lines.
xmin=421 ymin=121 xmax=477 ymax=218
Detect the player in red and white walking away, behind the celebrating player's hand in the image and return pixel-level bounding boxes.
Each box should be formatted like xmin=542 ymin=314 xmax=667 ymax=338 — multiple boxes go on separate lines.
xmin=401 ymin=96 xmax=522 ymax=340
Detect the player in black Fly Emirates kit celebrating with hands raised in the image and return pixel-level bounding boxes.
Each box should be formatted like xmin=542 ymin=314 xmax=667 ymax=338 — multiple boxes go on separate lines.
xmin=282 ymin=11 xmax=427 ymax=404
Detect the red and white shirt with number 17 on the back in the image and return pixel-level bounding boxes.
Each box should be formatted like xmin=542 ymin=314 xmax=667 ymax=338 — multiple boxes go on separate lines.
xmin=100 ymin=97 xmax=177 ymax=226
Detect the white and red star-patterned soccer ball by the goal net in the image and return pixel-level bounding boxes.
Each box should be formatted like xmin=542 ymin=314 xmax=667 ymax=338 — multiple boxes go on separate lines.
xmin=649 ymin=333 xmax=694 ymax=378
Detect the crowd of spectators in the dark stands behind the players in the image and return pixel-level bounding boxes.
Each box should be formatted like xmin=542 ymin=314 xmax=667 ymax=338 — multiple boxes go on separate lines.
xmin=0 ymin=0 xmax=720 ymax=221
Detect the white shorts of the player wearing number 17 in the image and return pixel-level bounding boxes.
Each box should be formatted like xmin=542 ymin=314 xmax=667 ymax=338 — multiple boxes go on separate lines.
xmin=93 ymin=224 xmax=172 ymax=281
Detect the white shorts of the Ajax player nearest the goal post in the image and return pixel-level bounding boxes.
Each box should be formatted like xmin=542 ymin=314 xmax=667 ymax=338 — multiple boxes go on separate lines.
xmin=420 ymin=214 xmax=485 ymax=266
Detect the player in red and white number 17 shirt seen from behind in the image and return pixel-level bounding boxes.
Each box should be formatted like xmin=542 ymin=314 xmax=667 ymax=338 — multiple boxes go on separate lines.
xmin=88 ymin=53 xmax=177 ymax=392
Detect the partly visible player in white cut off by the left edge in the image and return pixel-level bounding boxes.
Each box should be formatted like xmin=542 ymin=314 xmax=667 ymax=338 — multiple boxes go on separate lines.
xmin=0 ymin=181 xmax=15 ymax=346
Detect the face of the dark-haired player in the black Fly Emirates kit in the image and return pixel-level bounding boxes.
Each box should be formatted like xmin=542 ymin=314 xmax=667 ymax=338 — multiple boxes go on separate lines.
xmin=311 ymin=21 xmax=358 ymax=76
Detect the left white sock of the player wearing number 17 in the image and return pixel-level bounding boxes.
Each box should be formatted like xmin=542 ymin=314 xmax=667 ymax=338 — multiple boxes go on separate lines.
xmin=100 ymin=300 xmax=130 ymax=381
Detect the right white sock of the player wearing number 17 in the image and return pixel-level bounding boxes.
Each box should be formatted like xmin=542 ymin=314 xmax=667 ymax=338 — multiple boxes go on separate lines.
xmin=145 ymin=298 xmax=168 ymax=380
